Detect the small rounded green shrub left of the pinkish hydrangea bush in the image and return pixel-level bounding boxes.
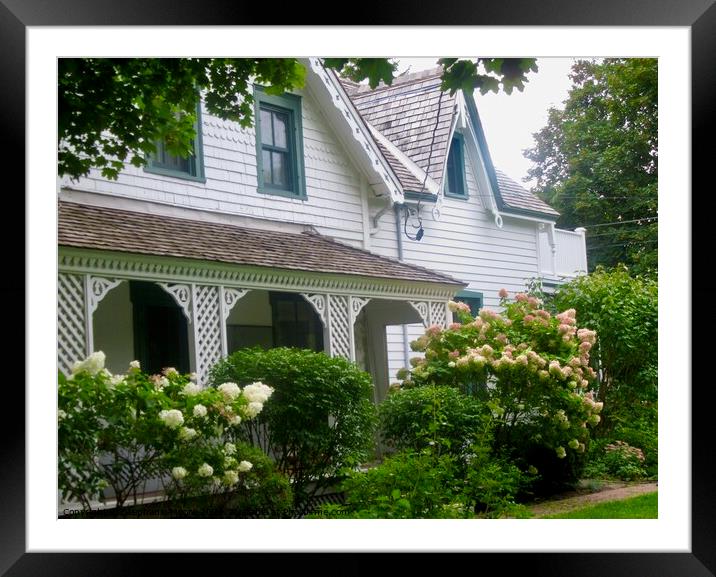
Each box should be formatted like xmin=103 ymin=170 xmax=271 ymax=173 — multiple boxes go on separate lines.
xmin=378 ymin=385 xmax=490 ymax=456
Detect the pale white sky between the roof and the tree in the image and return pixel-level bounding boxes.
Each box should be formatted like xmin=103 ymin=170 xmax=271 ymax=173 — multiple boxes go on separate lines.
xmin=397 ymin=58 xmax=574 ymax=188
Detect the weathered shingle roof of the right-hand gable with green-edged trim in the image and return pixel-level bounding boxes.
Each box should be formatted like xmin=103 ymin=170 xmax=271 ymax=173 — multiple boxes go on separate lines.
xmin=341 ymin=68 xmax=559 ymax=220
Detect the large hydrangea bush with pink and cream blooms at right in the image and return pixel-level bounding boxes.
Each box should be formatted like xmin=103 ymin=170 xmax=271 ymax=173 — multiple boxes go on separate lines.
xmin=399 ymin=289 xmax=603 ymax=488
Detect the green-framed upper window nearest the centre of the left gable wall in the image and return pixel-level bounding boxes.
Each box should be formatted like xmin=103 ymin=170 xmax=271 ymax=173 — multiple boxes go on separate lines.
xmin=254 ymin=86 xmax=306 ymax=199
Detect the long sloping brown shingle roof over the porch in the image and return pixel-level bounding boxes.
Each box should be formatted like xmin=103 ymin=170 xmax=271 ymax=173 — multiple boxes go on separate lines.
xmin=58 ymin=202 xmax=465 ymax=286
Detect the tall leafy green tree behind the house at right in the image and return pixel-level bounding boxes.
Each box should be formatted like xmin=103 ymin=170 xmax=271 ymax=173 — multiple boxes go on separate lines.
xmin=524 ymin=58 xmax=658 ymax=273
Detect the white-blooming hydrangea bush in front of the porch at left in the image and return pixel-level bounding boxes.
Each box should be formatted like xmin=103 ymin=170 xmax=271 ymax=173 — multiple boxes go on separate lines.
xmin=58 ymin=352 xmax=273 ymax=507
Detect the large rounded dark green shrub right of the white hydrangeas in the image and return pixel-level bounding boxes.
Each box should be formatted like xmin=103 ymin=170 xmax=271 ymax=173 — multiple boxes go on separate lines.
xmin=210 ymin=348 xmax=375 ymax=500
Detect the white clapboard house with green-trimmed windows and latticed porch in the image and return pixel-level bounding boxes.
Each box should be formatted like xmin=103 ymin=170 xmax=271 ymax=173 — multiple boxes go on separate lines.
xmin=58 ymin=58 xmax=586 ymax=400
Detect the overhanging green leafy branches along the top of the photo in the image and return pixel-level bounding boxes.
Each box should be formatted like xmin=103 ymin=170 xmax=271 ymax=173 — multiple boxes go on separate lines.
xmin=58 ymin=58 xmax=537 ymax=179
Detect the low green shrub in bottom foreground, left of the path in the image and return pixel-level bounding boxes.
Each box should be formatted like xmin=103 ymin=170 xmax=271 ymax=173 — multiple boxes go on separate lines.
xmin=313 ymin=449 xmax=465 ymax=519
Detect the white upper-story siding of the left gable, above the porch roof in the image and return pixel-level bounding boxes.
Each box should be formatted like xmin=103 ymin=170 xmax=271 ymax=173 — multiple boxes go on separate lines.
xmin=58 ymin=89 xmax=363 ymax=247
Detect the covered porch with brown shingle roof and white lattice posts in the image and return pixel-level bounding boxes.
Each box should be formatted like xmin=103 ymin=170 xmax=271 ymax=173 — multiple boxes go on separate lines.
xmin=58 ymin=203 xmax=464 ymax=394
